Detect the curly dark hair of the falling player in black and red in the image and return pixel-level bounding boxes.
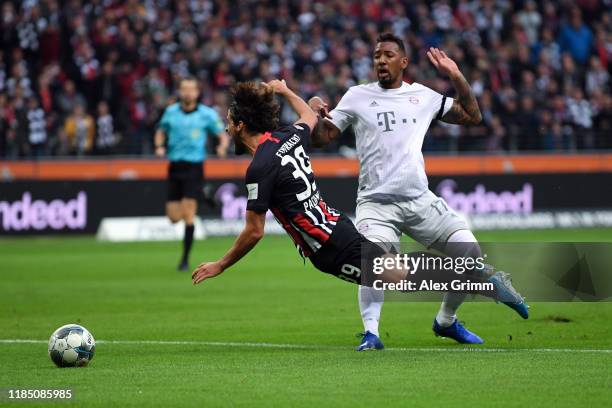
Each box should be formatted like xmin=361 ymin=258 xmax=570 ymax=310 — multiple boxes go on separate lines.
xmin=229 ymin=82 xmax=280 ymax=133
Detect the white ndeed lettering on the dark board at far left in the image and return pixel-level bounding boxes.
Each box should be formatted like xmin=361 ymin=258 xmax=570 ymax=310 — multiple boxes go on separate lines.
xmin=0 ymin=191 xmax=87 ymax=231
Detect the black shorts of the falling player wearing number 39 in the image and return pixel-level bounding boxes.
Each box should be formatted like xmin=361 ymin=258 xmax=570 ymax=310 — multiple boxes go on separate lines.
xmin=310 ymin=215 xmax=387 ymax=285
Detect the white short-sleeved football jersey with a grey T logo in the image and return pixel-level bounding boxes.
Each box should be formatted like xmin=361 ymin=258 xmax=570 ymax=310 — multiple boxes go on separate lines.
xmin=330 ymin=82 xmax=453 ymax=201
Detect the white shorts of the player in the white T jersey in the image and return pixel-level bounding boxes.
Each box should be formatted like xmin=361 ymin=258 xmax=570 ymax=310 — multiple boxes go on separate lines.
xmin=356 ymin=190 xmax=469 ymax=248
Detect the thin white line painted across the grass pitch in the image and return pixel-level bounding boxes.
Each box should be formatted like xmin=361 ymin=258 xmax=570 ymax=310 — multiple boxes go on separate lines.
xmin=0 ymin=339 xmax=612 ymax=353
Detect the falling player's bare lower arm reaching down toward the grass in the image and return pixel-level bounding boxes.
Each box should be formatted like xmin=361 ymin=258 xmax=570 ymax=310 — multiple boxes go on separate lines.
xmin=191 ymin=210 xmax=266 ymax=285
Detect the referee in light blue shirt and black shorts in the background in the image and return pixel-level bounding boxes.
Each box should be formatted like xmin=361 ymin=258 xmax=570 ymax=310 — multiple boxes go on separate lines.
xmin=155 ymin=77 xmax=229 ymax=271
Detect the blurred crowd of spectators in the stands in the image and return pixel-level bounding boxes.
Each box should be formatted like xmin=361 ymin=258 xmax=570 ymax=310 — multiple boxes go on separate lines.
xmin=0 ymin=0 xmax=612 ymax=158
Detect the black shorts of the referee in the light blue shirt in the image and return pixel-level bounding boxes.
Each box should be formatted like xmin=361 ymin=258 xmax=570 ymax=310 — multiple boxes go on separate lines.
xmin=167 ymin=162 xmax=204 ymax=201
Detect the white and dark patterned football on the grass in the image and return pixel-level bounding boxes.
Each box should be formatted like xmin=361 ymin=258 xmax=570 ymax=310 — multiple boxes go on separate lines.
xmin=49 ymin=324 xmax=96 ymax=367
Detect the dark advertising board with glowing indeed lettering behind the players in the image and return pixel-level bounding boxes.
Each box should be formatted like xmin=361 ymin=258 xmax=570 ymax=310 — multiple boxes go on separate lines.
xmin=0 ymin=161 xmax=612 ymax=235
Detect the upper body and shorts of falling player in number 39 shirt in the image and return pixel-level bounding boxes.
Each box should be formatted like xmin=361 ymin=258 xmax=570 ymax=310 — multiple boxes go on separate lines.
xmin=192 ymin=80 xmax=392 ymax=284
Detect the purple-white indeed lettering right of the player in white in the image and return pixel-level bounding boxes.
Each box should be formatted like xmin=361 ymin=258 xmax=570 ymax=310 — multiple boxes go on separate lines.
xmin=436 ymin=179 xmax=533 ymax=214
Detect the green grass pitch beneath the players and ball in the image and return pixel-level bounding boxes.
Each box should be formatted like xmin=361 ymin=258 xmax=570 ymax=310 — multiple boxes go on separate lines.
xmin=0 ymin=229 xmax=612 ymax=407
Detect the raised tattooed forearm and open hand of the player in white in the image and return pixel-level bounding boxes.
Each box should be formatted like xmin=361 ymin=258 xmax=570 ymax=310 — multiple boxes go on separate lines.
xmin=427 ymin=47 xmax=482 ymax=125
